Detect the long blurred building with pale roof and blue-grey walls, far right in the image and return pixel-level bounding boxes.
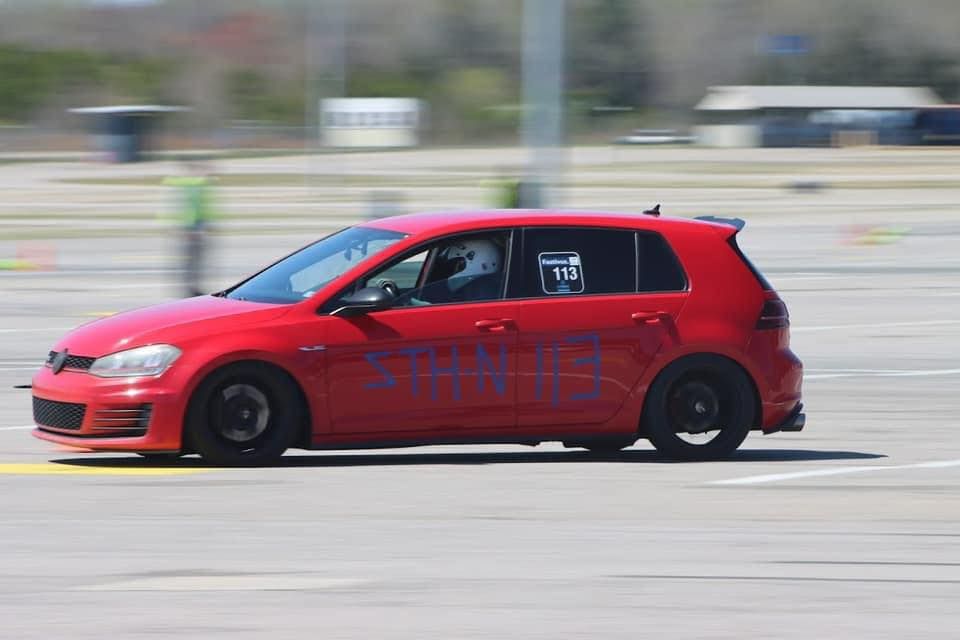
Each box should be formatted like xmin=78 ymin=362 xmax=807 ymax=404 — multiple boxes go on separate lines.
xmin=695 ymin=85 xmax=943 ymax=147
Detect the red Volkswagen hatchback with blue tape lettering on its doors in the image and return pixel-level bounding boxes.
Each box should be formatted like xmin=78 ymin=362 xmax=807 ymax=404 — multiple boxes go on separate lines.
xmin=33 ymin=211 xmax=804 ymax=465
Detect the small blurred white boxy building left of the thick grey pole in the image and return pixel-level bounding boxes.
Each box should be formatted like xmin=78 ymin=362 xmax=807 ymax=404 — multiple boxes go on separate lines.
xmin=320 ymin=98 xmax=421 ymax=148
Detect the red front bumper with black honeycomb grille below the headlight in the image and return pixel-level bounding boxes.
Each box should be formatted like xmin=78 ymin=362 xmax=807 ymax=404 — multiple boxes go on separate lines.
xmin=33 ymin=367 xmax=183 ymax=452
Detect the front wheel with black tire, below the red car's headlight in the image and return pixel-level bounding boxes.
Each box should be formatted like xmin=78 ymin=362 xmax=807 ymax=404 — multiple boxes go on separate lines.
xmin=184 ymin=362 xmax=303 ymax=467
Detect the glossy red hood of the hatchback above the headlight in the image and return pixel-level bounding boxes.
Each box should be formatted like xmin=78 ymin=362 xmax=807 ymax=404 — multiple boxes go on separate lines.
xmin=53 ymin=296 xmax=290 ymax=358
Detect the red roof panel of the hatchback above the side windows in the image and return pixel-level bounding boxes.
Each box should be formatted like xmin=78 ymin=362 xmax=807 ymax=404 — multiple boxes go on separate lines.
xmin=364 ymin=209 xmax=735 ymax=235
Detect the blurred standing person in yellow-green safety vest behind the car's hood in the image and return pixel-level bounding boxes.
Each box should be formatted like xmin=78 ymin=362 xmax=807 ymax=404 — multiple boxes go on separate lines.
xmin=163 ymin=161 xmax=216 ymax=297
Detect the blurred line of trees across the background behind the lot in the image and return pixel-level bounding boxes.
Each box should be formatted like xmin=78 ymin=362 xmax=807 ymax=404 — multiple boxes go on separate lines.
xmin=0 ymin=0 xmax=960 ymax=142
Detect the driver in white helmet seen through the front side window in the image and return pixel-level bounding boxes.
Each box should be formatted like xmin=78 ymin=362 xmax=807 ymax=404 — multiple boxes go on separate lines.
xmin=411 ymin=238 xmax=503 ymax=305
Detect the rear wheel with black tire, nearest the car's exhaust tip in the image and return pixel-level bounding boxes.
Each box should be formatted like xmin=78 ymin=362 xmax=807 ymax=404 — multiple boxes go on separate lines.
xmin=641 ymin=355 xmax=756 ymax=460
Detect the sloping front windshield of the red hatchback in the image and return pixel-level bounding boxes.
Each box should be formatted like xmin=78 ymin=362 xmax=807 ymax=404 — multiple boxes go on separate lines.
xmin=226 ymin=227 xmax=406 ymax=304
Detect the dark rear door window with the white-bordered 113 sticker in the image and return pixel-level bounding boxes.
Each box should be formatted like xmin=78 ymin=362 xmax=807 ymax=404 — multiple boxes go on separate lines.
xmin=511 ymin=227 xmax=637 ymax=298
